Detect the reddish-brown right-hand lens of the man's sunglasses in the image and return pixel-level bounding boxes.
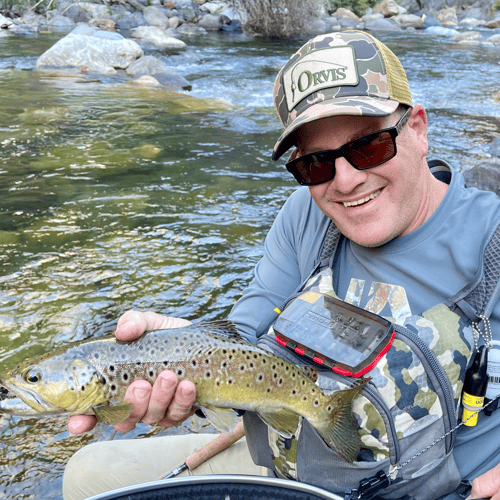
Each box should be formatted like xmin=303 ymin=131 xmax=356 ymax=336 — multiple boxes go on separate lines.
xmin=346 ymin=132 xmax=396 ymax=169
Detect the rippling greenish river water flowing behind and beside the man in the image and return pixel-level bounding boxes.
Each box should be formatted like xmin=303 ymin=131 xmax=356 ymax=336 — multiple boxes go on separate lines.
xmin=0 ymin=28 xmax=500 ymax=499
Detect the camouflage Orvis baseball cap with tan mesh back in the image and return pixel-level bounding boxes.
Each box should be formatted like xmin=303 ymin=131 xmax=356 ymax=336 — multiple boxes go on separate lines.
xmin=273 ymin=31 xmax=412 ymax=160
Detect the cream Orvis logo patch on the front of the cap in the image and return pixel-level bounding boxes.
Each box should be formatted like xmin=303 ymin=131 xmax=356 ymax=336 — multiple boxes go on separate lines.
xmin=283 ymin=46 xmax=359 ymax=111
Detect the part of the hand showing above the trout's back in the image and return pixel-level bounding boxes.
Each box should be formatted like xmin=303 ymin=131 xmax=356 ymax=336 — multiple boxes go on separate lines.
xmin=115 ymin=311 xmax=191 ymax=342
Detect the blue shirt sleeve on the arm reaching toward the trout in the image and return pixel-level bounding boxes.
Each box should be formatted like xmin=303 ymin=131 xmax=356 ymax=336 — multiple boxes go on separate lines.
xmin=229 ymin=188 xmax=328 ymax=343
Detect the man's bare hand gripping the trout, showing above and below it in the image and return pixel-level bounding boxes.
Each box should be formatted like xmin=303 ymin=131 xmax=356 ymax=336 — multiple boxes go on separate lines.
xmin=68 ymin=311 xmax=196 ymax=434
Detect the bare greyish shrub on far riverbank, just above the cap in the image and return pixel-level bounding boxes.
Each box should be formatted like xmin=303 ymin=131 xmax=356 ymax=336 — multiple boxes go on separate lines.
xmin=233 ymin=0 xmax=316 ymax=38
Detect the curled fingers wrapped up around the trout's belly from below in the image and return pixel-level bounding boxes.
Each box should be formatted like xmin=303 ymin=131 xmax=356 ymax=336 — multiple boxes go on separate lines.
xmin=114 ymin=370 xmax=196 ymax=432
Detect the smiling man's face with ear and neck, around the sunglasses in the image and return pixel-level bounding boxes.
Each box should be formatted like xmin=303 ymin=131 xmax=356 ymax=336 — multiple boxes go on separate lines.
xmin=297 ymin=105 xmax=440 ymax=247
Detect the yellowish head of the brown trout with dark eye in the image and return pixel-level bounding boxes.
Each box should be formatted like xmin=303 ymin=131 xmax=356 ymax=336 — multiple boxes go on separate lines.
xmin=0 ymin=354 xmax=107 ymax=415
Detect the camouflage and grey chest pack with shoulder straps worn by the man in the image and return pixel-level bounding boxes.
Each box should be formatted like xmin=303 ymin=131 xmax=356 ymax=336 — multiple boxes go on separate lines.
xmin=244 ymin=218 xmax=500 ymax=500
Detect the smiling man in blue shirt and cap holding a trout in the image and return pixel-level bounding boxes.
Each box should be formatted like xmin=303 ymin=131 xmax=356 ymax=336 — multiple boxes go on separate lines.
xmin=64 ymin=31 xmax=500 ymax=500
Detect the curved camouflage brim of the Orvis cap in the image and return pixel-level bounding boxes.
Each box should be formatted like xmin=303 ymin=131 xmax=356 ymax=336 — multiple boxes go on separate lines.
xmin=272 ymin=96 xmax=400 ymax=161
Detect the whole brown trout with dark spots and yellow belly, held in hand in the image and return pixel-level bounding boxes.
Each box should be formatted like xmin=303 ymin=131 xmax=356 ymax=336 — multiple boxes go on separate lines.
xmin=0 ymin=321 xmax=367 ymax=462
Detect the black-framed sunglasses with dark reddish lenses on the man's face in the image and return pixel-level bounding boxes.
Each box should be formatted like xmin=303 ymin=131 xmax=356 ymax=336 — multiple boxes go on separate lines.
xmin=285 ymin=108 xmax=411 ymax=186
